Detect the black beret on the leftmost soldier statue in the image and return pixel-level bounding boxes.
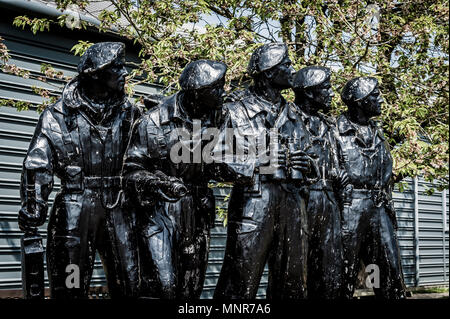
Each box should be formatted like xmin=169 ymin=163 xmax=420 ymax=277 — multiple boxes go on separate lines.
xmin=78 ymin=42 xmax=125 ymax=74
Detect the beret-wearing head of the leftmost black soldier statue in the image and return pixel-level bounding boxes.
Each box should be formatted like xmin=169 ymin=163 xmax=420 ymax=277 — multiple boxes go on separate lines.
xmin=78 ymin=42 xmax=128 ymax=94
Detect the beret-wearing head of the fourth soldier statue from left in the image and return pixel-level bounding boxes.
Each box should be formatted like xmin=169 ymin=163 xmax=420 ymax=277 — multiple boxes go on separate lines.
xmin=293 ymin=66 xmax=334 ymax=113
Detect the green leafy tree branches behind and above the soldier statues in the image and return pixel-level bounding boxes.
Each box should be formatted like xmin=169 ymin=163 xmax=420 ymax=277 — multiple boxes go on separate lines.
xmin=0 ymin=0 xmax=449 ymax=188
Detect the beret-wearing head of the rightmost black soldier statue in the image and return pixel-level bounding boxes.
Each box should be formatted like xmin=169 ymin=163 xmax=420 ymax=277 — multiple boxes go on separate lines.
xmin=341 ymin=76 xmax=384 ymax=117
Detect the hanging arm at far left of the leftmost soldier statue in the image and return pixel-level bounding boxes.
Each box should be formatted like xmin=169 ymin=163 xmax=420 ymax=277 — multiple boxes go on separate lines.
xmin=19 ymin=114 xmax=55 ymax=231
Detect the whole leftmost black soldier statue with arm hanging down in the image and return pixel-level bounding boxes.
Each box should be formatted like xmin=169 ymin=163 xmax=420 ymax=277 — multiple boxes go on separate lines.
xmin=19 ymin=42 xmax=141 ymax=298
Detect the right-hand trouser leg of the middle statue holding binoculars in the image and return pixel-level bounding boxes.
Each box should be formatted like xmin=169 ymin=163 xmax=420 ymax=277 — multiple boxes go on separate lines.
xmin=267 ymin=187 xmax=308 ymax=299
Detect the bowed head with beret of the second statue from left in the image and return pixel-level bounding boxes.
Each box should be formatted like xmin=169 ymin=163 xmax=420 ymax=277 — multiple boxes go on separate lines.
xmin=179 ymin=60 xmax=227 ymax=113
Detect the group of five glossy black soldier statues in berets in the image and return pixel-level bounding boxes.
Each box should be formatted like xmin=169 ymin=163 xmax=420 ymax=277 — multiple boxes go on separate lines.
xmin=19 ymin=42 xmax=405 ymax=299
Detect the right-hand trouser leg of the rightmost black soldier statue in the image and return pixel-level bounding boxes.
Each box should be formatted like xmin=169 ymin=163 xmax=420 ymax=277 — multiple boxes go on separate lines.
xmin=372 ymin=207 xmax=406 ymax=299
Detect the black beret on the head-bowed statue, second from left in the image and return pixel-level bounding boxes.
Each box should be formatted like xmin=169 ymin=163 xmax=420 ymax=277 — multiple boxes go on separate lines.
xmin=179 ymin=60 xmax=227 ymax=91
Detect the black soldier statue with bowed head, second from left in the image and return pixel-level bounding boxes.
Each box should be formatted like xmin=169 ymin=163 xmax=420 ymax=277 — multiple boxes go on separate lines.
xmin=124 ymin=60 xmax=227 ymax=299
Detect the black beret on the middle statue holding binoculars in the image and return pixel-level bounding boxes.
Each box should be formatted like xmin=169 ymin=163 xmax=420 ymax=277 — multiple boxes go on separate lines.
xmin=247 ymin=43 xmax=288 ymax=76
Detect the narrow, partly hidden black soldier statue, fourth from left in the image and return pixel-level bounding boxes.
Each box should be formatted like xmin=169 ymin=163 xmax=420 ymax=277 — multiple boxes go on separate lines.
xmin=293 ymin=66 xmax=346 ymax=299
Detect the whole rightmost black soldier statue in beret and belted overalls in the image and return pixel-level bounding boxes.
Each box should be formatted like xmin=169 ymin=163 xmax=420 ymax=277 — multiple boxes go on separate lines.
xmin=337 ymin=77 xmax=405 ymax=299
